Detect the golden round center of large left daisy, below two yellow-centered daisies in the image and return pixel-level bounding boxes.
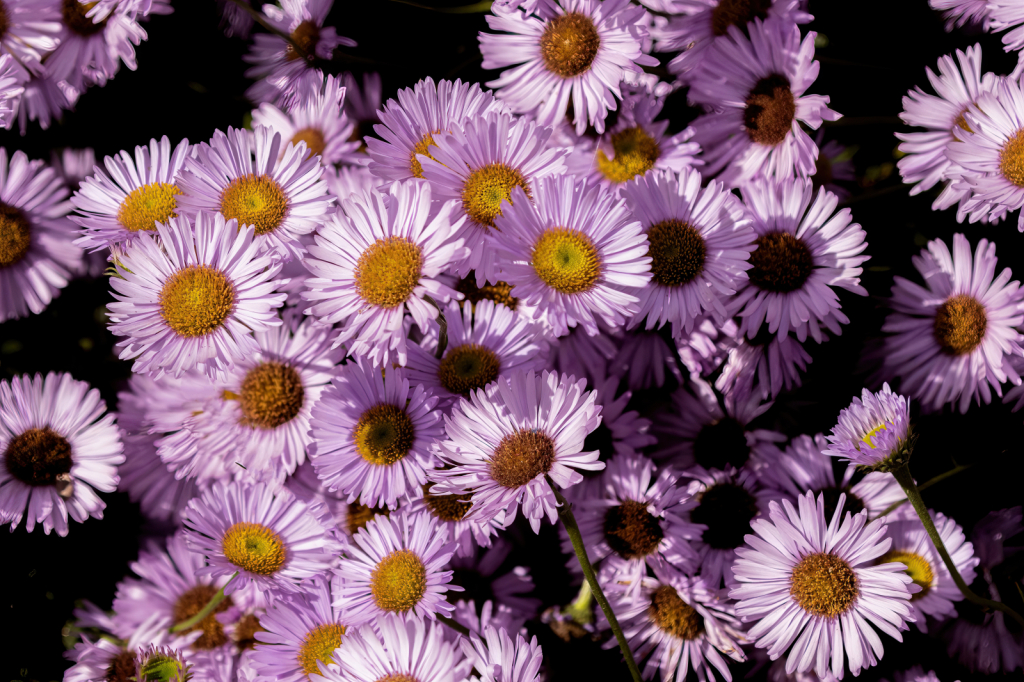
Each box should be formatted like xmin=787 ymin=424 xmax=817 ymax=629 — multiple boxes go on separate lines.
xmin=160 ymin=265 xmax=234 ymax=338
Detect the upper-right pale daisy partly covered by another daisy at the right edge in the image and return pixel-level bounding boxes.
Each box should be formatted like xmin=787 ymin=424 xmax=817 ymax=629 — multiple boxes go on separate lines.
xmin=896 ymin=45 xmax=997 ymax=210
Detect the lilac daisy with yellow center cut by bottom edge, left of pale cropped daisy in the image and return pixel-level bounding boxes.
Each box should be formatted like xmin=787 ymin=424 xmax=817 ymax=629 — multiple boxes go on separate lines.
xmin=250 ymin=578 xmax=348 ymax=682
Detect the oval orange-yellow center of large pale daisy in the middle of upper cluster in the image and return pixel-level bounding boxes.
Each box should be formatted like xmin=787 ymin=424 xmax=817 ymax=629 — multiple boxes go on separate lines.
xmin=355 ymin=237 xmax=423 ymax=308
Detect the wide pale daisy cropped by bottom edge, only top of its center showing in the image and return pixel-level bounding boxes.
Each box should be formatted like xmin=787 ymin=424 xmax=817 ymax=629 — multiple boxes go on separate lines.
xmin=325 ymin=617 xmax=472 ymax=682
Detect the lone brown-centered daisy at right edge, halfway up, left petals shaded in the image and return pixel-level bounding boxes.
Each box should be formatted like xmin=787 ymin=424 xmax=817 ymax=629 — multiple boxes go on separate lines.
xmin=882 ymin=235 xmax=1024 ymax=412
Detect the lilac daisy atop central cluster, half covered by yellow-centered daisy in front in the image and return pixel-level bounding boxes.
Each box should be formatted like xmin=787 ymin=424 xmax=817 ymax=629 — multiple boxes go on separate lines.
xmin=366 ymin=77 xmax=507 ymax=181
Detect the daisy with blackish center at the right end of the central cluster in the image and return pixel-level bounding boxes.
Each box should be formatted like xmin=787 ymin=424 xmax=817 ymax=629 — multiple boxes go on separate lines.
xmin=733 ymin=178 xmax=869 ymax=341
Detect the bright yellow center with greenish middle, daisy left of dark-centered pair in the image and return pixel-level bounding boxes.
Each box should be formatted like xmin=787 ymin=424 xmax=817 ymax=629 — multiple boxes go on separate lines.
xmin=531 ymin=227 xmax=601 ymax=294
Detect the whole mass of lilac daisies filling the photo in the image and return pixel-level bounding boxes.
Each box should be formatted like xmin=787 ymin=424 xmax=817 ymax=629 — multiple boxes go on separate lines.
xmin=0 ymin=0 xmax=1024 ymax=682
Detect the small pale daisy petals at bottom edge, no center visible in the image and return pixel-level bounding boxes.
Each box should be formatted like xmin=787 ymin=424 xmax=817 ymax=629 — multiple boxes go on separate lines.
xmin=462 ymin=626 xmax=544 ymax=682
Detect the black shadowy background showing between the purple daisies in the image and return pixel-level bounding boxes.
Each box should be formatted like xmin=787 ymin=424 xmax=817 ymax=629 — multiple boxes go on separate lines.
xmin=0 ymin=0 xmax=1024 ymax=682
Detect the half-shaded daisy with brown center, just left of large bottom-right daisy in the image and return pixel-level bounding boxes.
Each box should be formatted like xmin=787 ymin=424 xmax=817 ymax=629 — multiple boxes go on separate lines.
xmin=598 ymin=576 xmax=746 ymax=682
